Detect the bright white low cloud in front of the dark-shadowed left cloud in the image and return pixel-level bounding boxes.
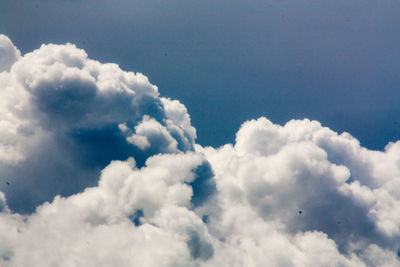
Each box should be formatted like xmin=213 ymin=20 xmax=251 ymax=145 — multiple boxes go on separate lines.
xmin=0 ymin=153 xmax=213 ymax=266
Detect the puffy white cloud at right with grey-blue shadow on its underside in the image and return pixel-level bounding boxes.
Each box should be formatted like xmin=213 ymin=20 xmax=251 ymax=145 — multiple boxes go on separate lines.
xmin=201 ymin=118 xmax=400 ymax=258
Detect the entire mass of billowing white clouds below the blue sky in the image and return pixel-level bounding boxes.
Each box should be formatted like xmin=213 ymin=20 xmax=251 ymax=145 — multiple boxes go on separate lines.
xmin=0 ymin=36 xmax=400 ymax=266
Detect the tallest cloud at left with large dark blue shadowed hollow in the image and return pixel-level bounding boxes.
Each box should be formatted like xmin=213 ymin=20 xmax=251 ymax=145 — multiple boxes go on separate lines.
xmin=0 ymin=35 xmax=196 ymax=212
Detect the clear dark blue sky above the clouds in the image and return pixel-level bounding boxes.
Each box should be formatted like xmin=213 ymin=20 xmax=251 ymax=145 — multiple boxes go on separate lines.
xmin=0 ymin=0 xmax=400 ymax=149
